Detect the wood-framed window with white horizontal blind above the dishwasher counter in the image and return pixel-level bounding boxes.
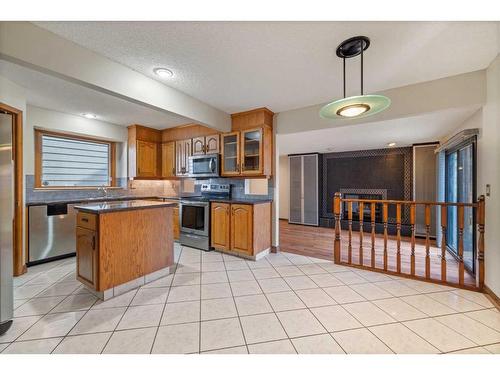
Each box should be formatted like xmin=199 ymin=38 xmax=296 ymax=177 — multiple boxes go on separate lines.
xmin=35 ymin=130 xmax=115 ymax=188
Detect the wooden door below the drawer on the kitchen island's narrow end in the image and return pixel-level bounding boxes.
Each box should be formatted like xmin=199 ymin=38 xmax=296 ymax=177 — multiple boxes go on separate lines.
xmin=76 ymin=227 xmax=99 ymax=288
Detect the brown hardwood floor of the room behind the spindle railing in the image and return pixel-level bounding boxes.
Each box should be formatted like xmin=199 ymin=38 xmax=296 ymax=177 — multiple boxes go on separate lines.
xmin=280 ymin=220 xmax=475 ymax=286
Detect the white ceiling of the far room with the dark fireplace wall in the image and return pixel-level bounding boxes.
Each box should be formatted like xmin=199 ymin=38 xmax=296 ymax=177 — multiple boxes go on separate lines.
xmin=278 ymin=108 xmax=479 ymax=155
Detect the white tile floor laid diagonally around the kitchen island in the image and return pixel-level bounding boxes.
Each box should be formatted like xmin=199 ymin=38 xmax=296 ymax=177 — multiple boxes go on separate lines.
xmin=0 ymin=244 xmax=500 ymax=354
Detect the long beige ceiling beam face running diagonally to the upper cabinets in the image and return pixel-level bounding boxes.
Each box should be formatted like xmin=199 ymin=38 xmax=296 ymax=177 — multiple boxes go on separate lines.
xmin=0 ymin=22 xmax=231 ymax=131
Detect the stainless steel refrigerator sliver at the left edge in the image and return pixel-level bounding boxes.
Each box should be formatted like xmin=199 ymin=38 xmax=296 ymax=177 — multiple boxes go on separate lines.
xmin=0 ymin=112 xmax=14 ymax=335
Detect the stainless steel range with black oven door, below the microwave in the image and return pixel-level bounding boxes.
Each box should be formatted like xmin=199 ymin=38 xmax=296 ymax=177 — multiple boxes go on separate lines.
xmin=179 ymin=184 xmax=231 ymax=251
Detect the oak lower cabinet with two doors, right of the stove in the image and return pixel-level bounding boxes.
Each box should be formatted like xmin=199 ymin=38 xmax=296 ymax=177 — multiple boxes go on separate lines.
xmin=211 ymin=202 xmax=271 ymax=257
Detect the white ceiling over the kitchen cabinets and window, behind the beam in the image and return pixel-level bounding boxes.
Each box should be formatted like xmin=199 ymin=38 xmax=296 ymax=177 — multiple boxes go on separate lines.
xmin=0 ymin=59 xmax=192 ymax=129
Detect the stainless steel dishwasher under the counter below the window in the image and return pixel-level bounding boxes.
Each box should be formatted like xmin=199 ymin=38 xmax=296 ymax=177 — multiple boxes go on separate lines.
xmin=28 ymin=203 xmax=78 ymax=266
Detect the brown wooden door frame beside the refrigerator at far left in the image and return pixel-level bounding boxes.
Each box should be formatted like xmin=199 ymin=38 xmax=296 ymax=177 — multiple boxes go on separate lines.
xmin=0 ymin=102 xmax=26 ymax=276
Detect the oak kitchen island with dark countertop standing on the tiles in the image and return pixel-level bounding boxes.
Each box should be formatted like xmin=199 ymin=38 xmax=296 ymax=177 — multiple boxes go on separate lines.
xmin=75 ymin=200 xmax=176 ymax=300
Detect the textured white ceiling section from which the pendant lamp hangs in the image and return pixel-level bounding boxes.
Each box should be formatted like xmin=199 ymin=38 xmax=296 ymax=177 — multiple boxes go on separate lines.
xmin=36 ymin=22 xmax=497 ymax=113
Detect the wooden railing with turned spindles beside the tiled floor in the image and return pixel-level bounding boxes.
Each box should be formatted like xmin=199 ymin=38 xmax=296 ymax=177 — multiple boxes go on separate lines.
xmin=333 ymin=193 xmax=485 ymax=290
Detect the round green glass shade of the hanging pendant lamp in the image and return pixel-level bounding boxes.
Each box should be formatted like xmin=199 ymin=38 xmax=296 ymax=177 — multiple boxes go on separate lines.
xmin=319 ymin=95 xmax=391 ymax=119
